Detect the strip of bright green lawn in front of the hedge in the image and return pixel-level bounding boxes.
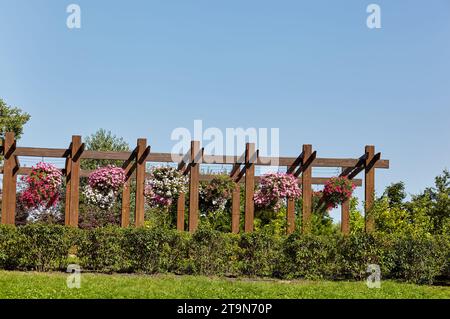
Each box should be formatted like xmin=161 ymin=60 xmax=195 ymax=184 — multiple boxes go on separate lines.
xmin=0 ymin=271 xmax=450 ymax=299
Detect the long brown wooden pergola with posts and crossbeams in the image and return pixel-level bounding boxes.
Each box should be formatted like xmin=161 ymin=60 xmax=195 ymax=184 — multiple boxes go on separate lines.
xmin=0 ymin=132 xmax=389 ymax=234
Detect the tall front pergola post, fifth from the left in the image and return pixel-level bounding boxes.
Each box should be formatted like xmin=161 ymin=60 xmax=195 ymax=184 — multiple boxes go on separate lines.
xmin=244 ymin=143 xmax=256 ymax=233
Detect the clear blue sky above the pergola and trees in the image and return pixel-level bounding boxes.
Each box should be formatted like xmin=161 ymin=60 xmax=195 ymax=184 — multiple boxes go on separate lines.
xmin=0 ymin=0 xmax=450 ymax=220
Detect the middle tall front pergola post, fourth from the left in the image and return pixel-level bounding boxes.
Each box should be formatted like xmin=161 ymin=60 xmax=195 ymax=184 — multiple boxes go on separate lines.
xmin=189 ymin=141 xmax=201 ymax=232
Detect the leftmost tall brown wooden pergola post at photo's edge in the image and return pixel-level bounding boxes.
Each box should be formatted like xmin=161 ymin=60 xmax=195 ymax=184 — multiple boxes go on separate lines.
xmin=2 ymin=132 xmax=18 ymax=225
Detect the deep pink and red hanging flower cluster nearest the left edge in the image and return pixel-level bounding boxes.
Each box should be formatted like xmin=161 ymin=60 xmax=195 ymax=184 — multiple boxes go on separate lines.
xmin=19 ymin=162 xmax=62 ymax=209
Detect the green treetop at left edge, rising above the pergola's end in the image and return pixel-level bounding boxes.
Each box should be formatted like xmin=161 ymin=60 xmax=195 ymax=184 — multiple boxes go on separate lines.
xmin=0 ymin=99 xmax=31 ymax=139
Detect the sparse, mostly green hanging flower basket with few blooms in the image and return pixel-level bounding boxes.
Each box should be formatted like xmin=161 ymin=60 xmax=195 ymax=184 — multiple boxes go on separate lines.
xmin=199 ymin=175 xmax=236 ymax=213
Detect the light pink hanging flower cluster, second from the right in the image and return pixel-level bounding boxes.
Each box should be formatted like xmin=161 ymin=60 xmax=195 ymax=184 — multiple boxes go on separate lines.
xmin=254 ymin=173 xmax=301 ymax=210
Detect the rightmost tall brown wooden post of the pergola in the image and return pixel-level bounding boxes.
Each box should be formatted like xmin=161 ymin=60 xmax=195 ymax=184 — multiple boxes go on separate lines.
xmin=364 ymin=145 xmax=375 ymax=233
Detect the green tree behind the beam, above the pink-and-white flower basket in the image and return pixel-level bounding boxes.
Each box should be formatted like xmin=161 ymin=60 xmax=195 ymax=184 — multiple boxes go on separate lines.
xmin=81 ymin=129 xmax=130 ymax=170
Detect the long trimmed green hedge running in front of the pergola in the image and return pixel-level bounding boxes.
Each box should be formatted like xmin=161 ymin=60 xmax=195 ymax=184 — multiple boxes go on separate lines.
xmin=0 ymin=224 xmax=450 ymax=284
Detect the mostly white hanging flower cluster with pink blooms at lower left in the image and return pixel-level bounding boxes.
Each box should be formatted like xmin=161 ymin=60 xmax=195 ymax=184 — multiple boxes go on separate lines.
xmin=145 ymin=166 xmax=187 ymax=207
